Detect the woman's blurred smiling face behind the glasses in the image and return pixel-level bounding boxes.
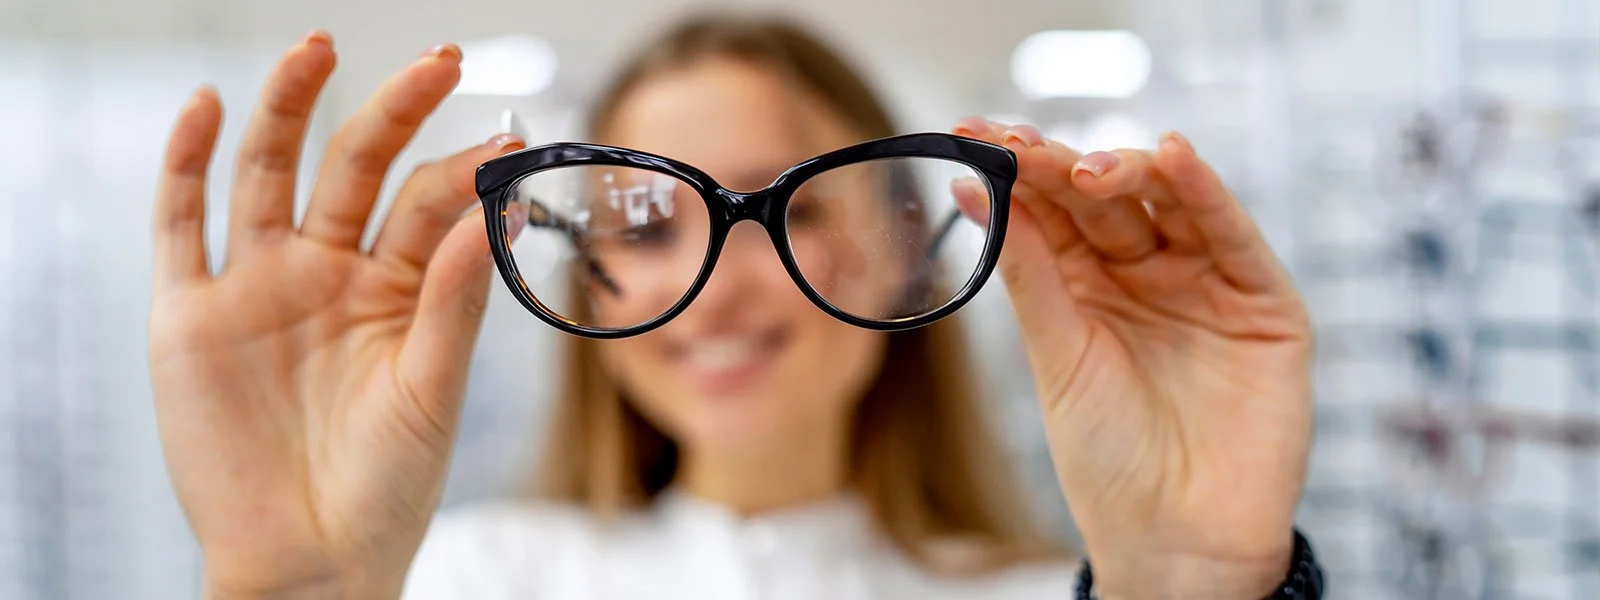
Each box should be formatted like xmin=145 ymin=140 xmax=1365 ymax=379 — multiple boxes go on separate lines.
xmin=589 ymin=59 xmax=907 ymax=450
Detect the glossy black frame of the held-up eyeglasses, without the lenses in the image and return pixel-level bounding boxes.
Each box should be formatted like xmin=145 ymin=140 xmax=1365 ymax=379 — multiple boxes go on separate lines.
xmin=477 ymin=133 xmax=1018 ymax=339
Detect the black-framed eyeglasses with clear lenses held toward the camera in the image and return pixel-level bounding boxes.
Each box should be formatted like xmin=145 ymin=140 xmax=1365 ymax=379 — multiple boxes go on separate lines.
xmin=477 ymin=133 xmax=1018 ymax=339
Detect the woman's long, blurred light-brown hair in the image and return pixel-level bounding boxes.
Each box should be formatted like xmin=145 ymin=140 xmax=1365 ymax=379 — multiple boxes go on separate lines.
xmin=536 ymin=8 xmax=1067 ymax=573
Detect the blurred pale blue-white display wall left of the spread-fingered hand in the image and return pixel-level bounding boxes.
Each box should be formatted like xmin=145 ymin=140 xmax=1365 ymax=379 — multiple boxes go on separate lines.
xmin=0 ymin=0 xmax=259 ymax=600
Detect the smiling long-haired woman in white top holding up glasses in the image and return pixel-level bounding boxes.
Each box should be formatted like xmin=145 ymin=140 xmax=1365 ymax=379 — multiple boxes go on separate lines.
xmin=150 ymin=9 xmax=1310 ymax=598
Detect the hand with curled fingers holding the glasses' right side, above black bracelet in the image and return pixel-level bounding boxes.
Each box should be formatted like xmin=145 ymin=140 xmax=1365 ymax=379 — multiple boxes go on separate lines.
xmin=955 ymin=118 xmax=1312 ymax=600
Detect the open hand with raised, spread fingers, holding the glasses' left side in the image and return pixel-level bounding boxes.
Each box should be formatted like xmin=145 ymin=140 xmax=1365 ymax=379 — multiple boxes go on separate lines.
xmin=149 ymin=32 xmax=522 ymax=597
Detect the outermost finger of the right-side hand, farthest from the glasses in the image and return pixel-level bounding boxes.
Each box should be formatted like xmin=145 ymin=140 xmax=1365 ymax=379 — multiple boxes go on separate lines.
xmin=1155 ymin=133 xmax=1290 ymax=293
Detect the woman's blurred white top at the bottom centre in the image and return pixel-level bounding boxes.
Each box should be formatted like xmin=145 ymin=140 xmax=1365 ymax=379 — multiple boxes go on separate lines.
xmin=402 ymin=491 xmax=1077 ymax=600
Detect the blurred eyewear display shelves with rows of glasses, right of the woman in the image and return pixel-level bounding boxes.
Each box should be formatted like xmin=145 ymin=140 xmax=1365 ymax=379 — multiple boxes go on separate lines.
xmin=1294 ymin=0 xmax=1600 ymax=600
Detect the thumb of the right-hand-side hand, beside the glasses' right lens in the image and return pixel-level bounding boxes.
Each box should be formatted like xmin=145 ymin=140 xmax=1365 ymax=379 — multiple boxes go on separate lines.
xmin=997 ymin=202 xmax=1090 ymax=408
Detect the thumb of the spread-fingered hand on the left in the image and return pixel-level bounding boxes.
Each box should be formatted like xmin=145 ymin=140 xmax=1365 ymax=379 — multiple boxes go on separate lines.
xmin=395 ymin=210 xmax=494 ymax=422
